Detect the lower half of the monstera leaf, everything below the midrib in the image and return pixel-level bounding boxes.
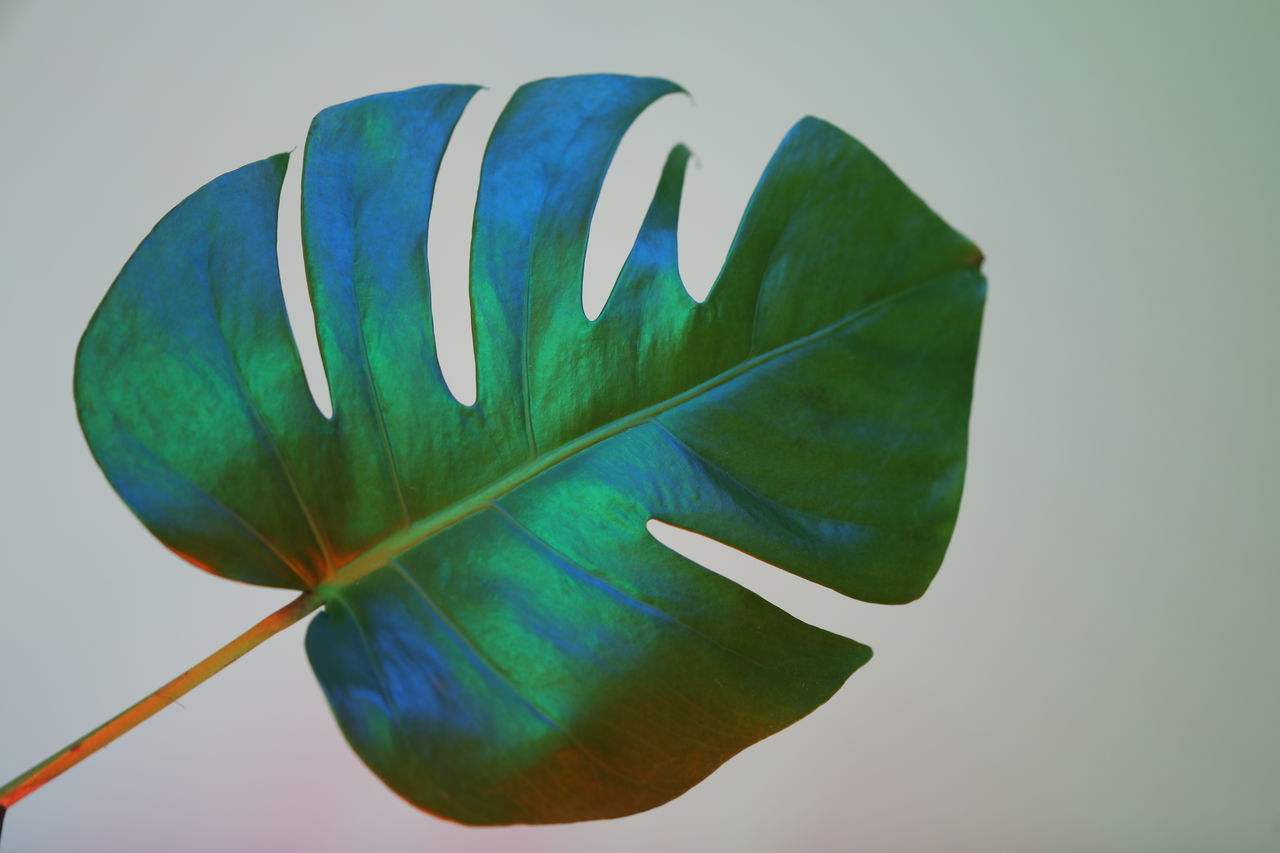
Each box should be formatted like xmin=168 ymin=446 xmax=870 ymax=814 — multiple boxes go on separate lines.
xmin=307 ymin=261 xmax=980 ymax=824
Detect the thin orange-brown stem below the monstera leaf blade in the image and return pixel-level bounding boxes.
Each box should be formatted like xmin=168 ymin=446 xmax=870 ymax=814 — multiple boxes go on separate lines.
xmin=0 ymin=592 xmax=324 ymax=816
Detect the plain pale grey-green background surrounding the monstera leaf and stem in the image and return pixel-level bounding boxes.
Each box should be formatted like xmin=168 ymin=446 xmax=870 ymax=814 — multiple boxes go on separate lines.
xmin=0 ymin=0 xmax=1280 ymax=853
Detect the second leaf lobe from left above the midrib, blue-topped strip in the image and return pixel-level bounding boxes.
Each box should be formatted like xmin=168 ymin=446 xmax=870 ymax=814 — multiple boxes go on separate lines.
xmin=300 ymin=86 xmax=483 ymax=545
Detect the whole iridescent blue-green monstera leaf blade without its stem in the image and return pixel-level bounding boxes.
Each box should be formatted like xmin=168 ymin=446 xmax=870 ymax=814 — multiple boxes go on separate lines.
xmin=64 ymin=76 xmax=984 ymax=824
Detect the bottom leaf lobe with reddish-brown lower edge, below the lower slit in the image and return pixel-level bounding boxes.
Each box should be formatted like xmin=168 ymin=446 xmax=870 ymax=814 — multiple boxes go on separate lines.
xmin=307 ymin=502 xmax=870 ymax=824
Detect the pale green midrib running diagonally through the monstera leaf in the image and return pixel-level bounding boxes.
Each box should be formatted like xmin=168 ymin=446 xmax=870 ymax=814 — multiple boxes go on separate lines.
xmin=315 ymin=272 xmax=966 ymax=601
